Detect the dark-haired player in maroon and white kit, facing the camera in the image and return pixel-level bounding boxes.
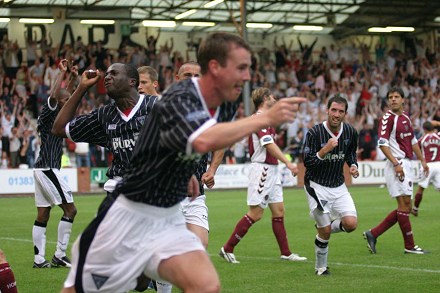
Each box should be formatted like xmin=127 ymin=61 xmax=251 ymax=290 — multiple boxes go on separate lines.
xmin=364 ymin=87 xmax=429 ymax=254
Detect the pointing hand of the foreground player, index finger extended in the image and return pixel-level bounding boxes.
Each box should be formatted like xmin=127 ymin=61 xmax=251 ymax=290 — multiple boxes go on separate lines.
xmin=266 ymin=97 xmax=307 ymax=126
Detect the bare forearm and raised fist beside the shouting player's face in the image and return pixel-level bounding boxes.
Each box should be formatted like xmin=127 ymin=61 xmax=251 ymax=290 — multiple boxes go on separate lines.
xmin=52 ymin=71 xmax=100 ymax=137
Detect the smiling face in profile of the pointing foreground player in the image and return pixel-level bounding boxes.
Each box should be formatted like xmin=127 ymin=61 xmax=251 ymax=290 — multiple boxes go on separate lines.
xmin=217 ymin=45 xmax=251 ymax=101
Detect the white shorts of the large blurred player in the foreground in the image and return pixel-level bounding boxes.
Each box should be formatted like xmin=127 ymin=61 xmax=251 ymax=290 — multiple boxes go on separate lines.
xmin=64 ymin=194 xmax=205 ymax=293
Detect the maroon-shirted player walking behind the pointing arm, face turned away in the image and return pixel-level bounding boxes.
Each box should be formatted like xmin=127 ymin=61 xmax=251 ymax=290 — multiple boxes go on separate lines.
xmin=219 ymin=88 xmax=307 ymax=263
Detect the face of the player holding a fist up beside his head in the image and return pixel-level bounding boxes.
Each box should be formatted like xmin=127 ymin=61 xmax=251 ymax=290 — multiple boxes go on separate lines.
xmin=104 ymin=63 xmax=130 ymax=99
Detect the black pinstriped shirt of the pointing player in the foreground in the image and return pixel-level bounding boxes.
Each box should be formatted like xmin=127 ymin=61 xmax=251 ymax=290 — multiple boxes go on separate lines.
xmin=115 ymin=79 xmax=234 ymax=207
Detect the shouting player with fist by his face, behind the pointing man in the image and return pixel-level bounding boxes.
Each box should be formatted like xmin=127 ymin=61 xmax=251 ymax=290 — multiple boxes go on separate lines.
xmin=52 ymin=63 xmax=157 ymax=194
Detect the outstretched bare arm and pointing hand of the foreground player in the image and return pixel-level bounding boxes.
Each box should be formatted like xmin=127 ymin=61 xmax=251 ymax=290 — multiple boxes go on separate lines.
xmin=190 ymin=98 xmax=306 ymax=153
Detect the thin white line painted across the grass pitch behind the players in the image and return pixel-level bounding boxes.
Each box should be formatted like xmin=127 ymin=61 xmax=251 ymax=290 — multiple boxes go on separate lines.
xmin=0 ymin=237 xmax=440 ymax=274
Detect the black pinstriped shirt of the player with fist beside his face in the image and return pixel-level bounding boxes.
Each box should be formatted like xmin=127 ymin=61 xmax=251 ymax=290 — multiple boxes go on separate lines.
xmin=66 ymin=95 xmax=157 ymax=178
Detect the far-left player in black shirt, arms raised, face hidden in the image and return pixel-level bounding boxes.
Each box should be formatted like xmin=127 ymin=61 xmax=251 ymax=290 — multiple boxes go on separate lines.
xmin=32 ymin=59 xmax=78 ymax=268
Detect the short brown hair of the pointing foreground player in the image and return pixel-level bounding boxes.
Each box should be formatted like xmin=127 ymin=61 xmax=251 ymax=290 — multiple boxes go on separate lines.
xmin=197 ymin=32 xmax=251 ymax=74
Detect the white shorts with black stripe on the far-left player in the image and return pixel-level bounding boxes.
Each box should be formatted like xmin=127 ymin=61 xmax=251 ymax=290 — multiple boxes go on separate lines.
xmin=34 ymin=169 xmax=73 ymax=207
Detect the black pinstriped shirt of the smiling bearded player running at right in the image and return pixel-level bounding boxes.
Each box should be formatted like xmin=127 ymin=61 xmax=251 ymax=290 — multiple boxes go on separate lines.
xmin=304 ymin=121 xmax=358 ymax=187
